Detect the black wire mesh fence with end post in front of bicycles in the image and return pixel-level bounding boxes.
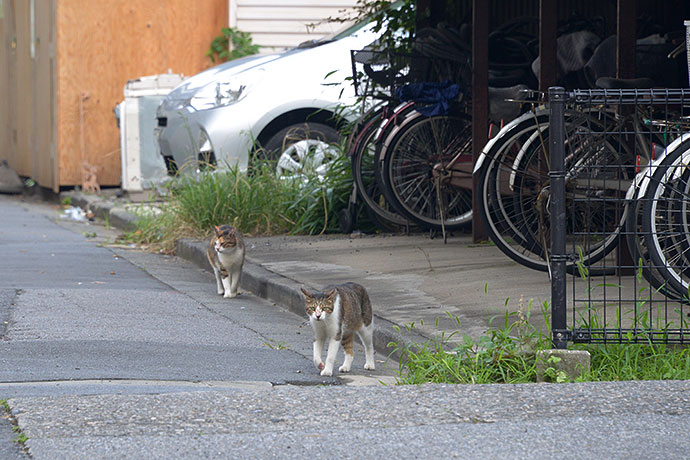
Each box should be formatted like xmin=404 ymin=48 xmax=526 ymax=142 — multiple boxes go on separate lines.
xmin=552 ymin=88 xmax=690 ymax=348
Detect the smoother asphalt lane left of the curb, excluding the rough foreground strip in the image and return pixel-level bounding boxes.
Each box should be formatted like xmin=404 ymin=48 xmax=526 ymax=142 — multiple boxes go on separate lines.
xmin=0 ymin=195 xmax=393 ymax=459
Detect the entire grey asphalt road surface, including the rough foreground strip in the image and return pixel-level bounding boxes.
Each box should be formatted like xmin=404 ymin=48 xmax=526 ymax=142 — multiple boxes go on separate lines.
xmin=0 ymin=197 xmax=690 ymax=460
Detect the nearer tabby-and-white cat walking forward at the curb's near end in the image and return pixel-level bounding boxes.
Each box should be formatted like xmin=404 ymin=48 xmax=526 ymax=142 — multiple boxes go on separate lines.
xmin=301 ymin=283 xmax=375 ymax=376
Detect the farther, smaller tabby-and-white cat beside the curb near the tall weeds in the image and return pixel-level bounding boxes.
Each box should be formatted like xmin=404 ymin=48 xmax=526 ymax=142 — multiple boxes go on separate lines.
xmin=206 ymin=225 xmax=244 ymax=298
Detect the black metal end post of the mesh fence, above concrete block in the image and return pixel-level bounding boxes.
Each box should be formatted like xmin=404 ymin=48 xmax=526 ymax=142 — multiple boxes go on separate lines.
xmin=549 ymin=86 xmax=569 ymax=349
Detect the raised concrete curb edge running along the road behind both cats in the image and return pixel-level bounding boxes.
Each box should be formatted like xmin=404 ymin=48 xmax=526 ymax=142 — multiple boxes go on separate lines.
xmin=66 ymin=192 xmax=430 ymax=361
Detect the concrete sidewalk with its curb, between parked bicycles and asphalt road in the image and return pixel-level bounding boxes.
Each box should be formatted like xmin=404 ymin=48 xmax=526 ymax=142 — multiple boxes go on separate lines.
xmin=66 ymin=192 xmax=550 ymax=356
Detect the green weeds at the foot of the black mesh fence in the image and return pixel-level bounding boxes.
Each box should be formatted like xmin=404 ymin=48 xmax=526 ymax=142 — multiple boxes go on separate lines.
xmin=389 ymin=296 xmax=690 ymax=384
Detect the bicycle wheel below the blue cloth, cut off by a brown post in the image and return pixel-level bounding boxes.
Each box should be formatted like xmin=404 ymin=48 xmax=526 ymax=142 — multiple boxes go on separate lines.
xmin=377 ymin=114 xmax=472 ymax=230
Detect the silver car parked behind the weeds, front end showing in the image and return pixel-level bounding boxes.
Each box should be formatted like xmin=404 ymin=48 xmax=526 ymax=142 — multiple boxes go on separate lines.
xmin=155 ymin=18 xmax=376 ymax=174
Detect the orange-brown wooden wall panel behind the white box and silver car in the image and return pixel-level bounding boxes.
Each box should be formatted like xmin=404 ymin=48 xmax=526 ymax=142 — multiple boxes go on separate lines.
xmin=56 ymin=0 xmax=228 ymax=186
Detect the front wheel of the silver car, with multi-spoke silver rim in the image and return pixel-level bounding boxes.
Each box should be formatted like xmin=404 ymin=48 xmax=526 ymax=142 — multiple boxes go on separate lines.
xmin=254 ymin=122 xmax=340 ymax=177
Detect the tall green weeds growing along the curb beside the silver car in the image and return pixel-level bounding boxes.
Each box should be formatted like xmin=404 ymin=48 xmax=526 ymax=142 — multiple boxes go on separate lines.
xmin=120 ymin=149 xmax=352 ymax=252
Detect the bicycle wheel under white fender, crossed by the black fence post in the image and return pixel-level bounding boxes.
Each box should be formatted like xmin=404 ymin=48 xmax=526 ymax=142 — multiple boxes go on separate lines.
xmin=477 ymin=110 xmax=630 ymax=271
